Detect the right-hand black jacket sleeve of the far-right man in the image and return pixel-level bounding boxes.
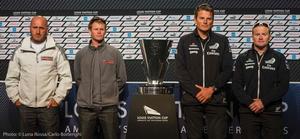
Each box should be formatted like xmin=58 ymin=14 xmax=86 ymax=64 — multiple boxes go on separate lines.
xmin=262 ymin=55 xmax=290 ymax=106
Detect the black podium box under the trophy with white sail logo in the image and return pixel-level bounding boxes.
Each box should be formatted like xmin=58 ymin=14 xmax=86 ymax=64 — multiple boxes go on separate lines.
xmin=126 ymin=94 xmax=179 ymax=139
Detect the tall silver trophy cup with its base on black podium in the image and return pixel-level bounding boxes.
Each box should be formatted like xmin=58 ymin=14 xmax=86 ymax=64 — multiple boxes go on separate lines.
xmin=139 ymin=40 xmax=172 ymax=94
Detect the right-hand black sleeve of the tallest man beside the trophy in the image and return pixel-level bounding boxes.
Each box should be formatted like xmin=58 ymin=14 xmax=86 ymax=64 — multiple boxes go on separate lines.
xmin=214 ymin=38 xmax=233 ymax=89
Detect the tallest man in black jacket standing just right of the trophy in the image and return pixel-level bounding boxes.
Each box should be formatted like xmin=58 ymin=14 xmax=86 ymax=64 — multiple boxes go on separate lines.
xmin=175 ymin=4 xmax=233 ymax=139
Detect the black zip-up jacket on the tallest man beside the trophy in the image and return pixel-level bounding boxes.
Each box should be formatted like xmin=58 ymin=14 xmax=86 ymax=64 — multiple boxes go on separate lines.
xmin=175 ymin=29 xmax=233 ymax=105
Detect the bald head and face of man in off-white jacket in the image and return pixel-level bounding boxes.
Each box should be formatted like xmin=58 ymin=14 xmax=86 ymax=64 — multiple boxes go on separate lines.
xmin=30 ymin=17 xmax=48 ymax=44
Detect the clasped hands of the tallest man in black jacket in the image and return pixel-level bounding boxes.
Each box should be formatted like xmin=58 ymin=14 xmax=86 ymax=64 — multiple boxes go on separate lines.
xmin=195 ymin=84 xmax=214 ymax=104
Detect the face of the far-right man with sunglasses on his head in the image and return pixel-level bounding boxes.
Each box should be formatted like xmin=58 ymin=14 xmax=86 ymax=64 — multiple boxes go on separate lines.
xmin=252 ymin=26 xmax=271 ymax=49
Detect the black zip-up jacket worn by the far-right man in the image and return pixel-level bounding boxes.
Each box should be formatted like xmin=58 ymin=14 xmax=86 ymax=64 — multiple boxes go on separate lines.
xmin=232 ymin=46 xmax=289 ymax=112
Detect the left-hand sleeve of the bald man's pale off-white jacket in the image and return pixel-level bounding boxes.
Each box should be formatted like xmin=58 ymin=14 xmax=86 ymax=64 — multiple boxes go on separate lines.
xmin=5 ymin=49 xmax=20 ymax=103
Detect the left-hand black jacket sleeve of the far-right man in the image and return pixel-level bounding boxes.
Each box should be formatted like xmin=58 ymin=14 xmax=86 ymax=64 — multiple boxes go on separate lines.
xmin=232 ymin=56 xmax=253 ymax=106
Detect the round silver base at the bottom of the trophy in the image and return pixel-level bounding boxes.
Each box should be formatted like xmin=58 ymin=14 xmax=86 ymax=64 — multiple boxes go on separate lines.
xmin=138 ymin=86 xmax=171 ymax=95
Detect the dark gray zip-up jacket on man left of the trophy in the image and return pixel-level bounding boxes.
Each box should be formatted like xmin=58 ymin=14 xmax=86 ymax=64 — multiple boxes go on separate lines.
xmin=74 ymin=42 xmax=127 ymax=108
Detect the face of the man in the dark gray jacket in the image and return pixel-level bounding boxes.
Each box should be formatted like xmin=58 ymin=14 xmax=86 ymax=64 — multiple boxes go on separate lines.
xmin=89 ymin=22 xmax=106 ymax=42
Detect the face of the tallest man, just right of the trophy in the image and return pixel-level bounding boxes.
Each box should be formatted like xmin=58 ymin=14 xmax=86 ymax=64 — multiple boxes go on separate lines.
xmin=194 ymin=10 xmax=214 ymax=32
